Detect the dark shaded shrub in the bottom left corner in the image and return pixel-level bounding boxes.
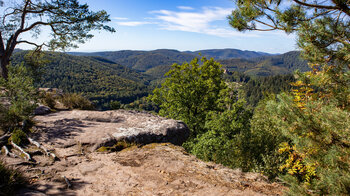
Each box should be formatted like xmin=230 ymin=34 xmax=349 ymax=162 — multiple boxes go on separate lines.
xmin=0 ymin=161 xmax=25 ymax=196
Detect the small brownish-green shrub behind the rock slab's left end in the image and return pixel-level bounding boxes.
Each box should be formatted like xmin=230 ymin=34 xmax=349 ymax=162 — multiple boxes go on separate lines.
xmin=61 ymin=93 xmax=94 ymax=110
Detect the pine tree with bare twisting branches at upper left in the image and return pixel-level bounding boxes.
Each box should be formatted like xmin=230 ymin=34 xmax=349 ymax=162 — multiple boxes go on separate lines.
xmin=0 ymin=0 xmax=115 ymax=80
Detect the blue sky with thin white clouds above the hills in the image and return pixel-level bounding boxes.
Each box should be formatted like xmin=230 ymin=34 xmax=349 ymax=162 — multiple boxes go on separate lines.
xmin=24 ymin=0 xmax=296 ymax=53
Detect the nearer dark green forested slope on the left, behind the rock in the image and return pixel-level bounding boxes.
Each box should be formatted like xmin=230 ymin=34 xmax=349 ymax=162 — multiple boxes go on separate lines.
xmin=12 ymin=51 xmax=151 ymax=108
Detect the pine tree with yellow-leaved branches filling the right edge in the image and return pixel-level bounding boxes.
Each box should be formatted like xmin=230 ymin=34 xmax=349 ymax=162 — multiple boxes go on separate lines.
xmin=229 ymin=0 xmax=350 ymax=195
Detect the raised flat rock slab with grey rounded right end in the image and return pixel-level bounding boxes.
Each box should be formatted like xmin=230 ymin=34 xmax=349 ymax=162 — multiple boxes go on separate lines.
xmin=34 ymin=110 xmax=189 ymax=151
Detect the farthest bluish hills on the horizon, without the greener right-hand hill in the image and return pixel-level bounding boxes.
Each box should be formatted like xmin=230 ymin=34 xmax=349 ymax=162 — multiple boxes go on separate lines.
xmin=70 ymin=49 xmax=271 ymax=71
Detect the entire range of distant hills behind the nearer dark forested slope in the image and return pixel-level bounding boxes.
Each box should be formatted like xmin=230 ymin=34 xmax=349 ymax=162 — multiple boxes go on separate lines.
xmin=71 ymin=49 xmax=309 ymax=78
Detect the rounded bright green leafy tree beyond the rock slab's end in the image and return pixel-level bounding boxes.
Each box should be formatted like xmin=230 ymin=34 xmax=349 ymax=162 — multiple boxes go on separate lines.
xmin=150 ymin=57 xmax=227 ymax=138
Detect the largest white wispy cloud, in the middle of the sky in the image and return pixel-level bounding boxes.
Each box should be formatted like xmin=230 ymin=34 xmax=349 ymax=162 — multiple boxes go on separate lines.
xmin=150 ymin=7 xmax=256 ymax=37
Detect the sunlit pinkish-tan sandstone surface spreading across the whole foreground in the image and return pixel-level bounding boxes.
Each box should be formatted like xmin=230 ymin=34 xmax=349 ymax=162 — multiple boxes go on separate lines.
xmin=2 ymin=111 xmax=284 ymax=196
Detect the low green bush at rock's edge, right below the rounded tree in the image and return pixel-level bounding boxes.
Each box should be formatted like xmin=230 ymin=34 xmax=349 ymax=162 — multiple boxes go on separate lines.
xmin=186 ymin=100 xmax=256 ymax=171
